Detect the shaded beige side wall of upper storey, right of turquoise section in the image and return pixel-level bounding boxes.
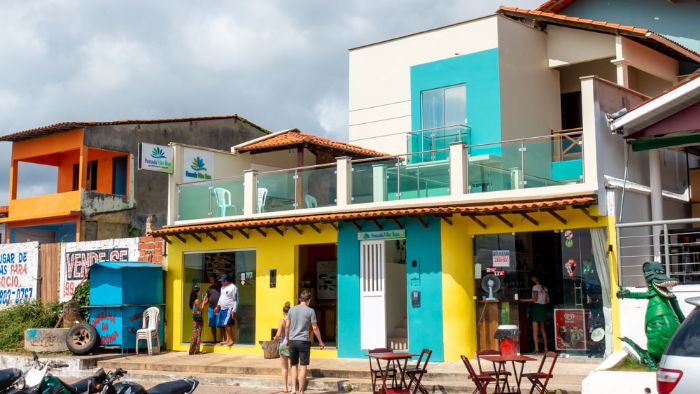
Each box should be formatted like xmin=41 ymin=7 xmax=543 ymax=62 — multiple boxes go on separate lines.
xmin=498 ymin=18 xmax=561 ymax=140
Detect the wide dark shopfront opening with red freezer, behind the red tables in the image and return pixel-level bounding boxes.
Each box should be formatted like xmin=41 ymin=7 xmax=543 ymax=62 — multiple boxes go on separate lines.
xmin=474 ymin=229 xmax=612 ymax=357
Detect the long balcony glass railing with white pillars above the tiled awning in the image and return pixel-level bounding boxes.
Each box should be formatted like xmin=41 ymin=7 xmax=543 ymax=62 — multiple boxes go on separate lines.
xmin=177 ymin=130 xmax=584 ymax=221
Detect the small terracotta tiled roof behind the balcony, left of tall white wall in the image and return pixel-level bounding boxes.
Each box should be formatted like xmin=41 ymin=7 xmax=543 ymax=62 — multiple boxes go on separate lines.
xmin=236 ymin=129 xmax=389 ymax=157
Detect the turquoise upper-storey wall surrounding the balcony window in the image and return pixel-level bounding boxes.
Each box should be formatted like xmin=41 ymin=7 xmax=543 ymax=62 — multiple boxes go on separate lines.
xmin=411 ymin=48 xmax=501 ymax=155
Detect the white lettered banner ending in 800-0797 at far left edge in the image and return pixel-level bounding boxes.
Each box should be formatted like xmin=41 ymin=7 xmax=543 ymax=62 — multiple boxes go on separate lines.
xmin=0 ymin=242 xmax=39 ymax=309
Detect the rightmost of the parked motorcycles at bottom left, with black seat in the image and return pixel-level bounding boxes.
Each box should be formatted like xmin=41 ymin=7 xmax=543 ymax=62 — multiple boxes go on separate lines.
xmin=90 ymin=368 xmax=199 ymax=394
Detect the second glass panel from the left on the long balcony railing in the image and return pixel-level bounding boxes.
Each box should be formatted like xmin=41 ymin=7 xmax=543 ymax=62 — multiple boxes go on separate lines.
xmin=257 ymin=170 xmax=297 ymax=213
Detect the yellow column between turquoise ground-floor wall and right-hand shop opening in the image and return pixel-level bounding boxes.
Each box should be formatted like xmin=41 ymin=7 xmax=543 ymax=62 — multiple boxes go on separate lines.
xmin=440 ymin=217 xmax=477 ymax=361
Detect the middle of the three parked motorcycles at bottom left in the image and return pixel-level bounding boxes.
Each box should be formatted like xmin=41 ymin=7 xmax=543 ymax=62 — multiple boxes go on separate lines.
xmin=5 ymin=352 xmax=106 ymax=394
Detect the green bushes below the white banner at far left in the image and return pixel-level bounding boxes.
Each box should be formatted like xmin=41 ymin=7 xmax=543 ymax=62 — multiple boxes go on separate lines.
xmin=0 ymin=300 xmax=62 ymax=350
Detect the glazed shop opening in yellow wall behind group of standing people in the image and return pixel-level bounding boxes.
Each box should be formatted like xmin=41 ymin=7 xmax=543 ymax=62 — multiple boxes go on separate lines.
xmin=181 ymin=250 xmax=255 ymax=345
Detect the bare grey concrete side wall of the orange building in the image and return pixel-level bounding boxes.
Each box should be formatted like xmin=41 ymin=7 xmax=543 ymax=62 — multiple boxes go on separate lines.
xmin=85 ymin=119 xmax=265 ymax=232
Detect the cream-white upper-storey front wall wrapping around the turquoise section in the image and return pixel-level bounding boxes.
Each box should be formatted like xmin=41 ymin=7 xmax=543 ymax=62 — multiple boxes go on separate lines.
xmin=349 ymin=15 xmax=505 ymax=154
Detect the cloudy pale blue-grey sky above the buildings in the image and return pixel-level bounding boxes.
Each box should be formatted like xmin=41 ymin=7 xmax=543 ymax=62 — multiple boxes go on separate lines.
xmin=0 ymin=0 xmax=543 ymax=204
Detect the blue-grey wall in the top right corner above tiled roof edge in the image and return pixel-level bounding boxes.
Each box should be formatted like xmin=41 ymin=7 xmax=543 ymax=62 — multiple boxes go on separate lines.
xmin=561 ymin=0 xmax=700 ymax=51
